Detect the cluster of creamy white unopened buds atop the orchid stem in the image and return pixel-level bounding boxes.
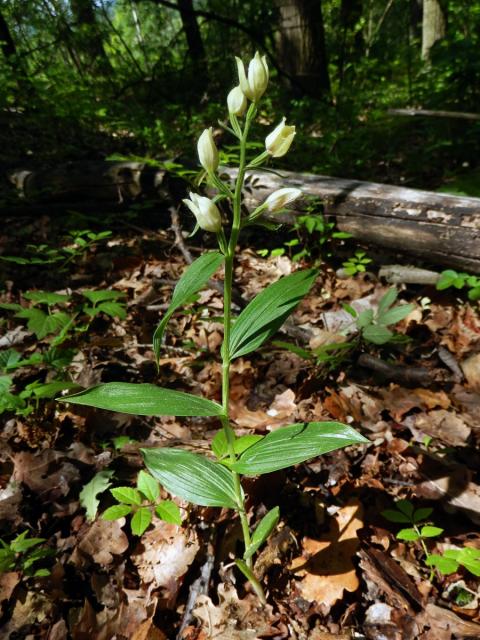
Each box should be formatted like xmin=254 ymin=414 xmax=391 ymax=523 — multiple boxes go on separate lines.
xmin=187 ymin=51 xmax=301 ymax=234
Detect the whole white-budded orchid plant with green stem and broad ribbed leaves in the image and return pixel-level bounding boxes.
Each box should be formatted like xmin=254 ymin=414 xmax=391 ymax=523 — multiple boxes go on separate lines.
xmin=61 ymin=53 xmax=367 ymax=603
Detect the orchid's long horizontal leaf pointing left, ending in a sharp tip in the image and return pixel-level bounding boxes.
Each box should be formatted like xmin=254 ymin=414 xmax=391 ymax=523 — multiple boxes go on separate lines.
xmin=58 ymin=382 xmax=223 ymax=416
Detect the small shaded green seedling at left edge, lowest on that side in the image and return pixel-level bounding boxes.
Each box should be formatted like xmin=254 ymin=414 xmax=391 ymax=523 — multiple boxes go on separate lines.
xmin=0 ymin=531 xmax=55 ymax=578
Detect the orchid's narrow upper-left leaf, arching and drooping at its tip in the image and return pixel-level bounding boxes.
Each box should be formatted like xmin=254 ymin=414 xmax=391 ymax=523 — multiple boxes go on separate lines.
xmin=153 ymin=251 xmax=223 ymax=363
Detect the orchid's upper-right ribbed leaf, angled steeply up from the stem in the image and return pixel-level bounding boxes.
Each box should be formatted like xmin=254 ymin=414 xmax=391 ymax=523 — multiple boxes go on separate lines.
xmin=229 ymin=269 xmax=317 ymax=359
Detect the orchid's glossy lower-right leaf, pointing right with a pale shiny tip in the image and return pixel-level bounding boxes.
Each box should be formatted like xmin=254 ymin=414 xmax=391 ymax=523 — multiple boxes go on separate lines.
xmin=232 ymin=422 xmax=369 ymax=476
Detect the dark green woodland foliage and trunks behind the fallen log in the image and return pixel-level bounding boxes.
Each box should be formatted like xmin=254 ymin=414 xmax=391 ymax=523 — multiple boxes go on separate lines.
xmin=0 ymin=0 xmax=480 ymax=190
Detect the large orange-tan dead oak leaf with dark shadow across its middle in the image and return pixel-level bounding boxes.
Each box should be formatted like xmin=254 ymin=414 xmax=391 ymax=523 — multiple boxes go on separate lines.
xmin=290 ymin=500 xmax=363 ymax=609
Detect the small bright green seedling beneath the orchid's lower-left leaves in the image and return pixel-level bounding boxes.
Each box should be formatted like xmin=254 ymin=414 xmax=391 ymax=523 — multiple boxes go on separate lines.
xmin=102 ymin=470 xmax=182 ymax=536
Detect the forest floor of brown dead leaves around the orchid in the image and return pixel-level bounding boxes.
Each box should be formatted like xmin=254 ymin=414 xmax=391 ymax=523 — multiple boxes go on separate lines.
xmin=0 ymin=206 xmax=480 ymax=640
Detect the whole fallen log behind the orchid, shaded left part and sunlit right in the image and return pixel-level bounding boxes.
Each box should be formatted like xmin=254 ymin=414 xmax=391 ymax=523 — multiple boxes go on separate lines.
xmin=5 ymin=161 xmax=480 ymax=273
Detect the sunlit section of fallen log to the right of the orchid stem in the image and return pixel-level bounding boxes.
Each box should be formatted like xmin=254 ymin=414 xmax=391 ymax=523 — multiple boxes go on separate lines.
xmin=226 ymin=169 xmax=480 ymax=273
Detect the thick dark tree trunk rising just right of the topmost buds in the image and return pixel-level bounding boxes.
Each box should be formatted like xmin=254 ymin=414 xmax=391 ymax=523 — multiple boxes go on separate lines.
xmin=277 ymin=0 xmax=330 ymax=98
